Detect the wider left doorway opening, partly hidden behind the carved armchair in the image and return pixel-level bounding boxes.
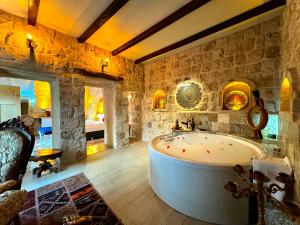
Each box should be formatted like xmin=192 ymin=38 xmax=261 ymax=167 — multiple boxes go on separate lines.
xmin=0 ymin=77 xmax=53 ymax=150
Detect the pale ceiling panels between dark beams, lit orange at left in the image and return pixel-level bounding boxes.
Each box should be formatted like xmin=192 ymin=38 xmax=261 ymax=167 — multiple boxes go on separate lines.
xmin=0 ymin=0 xmax=282 ymax=63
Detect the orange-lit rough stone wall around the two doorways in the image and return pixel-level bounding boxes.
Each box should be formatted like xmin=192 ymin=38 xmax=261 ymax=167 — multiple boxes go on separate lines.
xmin=0 ymin=11 xmax=144 ymax=161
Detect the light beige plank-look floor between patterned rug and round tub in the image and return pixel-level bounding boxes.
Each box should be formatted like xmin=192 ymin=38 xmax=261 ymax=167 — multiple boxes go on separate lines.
xmin=22 ymin=142 xmax=214 ymax=225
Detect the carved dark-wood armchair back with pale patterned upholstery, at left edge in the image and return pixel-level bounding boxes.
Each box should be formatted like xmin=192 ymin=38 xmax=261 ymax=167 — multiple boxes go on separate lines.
xmin=0 ymin=118 xmax=35 ymax=189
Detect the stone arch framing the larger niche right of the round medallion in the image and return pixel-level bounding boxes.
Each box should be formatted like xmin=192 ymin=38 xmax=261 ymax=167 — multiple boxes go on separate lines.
xmin=218 ymin=78 xmax=257 ymax=110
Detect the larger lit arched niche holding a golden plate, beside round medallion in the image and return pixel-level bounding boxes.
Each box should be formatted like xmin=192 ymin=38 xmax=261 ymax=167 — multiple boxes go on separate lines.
xmin=221 ymin=81 xmax=251 ymax=111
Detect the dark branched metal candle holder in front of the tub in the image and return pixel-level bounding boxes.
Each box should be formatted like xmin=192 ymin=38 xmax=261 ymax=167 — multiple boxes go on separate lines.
xmin=224 ymin=165 xmax=300 ymax=225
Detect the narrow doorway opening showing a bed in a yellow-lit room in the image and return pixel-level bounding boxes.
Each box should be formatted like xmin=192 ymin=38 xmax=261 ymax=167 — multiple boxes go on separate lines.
xmin=84 ymin=86 xmax=105 ymax=155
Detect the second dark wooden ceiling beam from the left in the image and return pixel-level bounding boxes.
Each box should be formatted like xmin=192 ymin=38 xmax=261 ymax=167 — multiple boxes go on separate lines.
xmin=77 ymin=0 xmax=129 ymax=43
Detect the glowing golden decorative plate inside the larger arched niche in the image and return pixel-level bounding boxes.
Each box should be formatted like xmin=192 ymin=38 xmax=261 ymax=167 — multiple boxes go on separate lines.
xmin=224 ymin=91 xmax=249 ymax=110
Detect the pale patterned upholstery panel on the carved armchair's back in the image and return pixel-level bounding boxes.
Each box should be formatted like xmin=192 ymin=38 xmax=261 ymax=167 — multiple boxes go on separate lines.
xmin=0 ymin=130 xmax=23 ymax=183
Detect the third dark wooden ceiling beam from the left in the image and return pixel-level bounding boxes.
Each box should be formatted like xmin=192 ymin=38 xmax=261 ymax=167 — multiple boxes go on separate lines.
xmin=111 ymin=0 xmax=211 ymax=56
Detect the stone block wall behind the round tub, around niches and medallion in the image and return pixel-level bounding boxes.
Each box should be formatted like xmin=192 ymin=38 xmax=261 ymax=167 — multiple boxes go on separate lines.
xmin=142 ymin=17 xmax=281 ymax=140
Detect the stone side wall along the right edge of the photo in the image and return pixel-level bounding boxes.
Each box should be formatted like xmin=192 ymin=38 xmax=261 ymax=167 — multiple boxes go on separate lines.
xmin=280 ymin=0 xmax=300 ymax=224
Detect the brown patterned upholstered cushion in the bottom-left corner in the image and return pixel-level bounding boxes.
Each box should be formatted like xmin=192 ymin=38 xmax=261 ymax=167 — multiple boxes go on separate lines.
xmin=0 ymin=190 xmax=27 ymax=225
